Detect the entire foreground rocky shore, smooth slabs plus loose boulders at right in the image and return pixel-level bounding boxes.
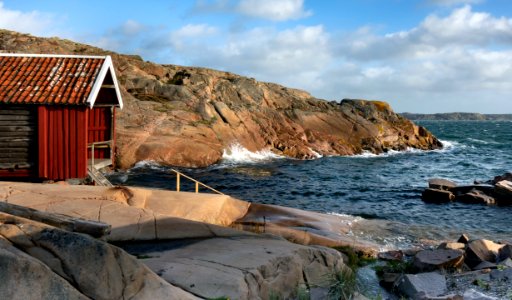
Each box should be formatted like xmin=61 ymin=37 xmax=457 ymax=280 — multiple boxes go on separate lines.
xmin=0 ymin=182 xmax=512 ymax=299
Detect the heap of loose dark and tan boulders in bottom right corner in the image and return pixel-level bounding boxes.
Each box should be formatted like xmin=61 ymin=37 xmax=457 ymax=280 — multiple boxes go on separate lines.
xmin=376 ymin=235 xmax=512 ymax=300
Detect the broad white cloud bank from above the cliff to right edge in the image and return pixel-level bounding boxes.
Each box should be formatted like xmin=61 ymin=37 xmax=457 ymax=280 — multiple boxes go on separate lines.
xmin=94 ymin=6 xmax=512 ymax=112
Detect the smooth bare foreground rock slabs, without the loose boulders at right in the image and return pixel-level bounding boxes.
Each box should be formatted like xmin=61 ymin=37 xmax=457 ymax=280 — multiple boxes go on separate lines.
xmin=0 ymin=182 xmax=378 ymax=299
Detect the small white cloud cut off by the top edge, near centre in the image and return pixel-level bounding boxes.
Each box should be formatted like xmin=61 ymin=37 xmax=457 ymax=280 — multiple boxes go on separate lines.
xmin=236 ymin=0 xmax=311 ymax=21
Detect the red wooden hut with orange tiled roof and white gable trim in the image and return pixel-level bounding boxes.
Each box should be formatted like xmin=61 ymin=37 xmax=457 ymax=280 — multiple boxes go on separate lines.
xmin=0 ymin=54 xmax=123 ymax=180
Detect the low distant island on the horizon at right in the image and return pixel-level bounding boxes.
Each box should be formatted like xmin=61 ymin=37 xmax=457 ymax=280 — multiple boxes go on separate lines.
xmin=400 ymin=112 xmax=512 ymax=121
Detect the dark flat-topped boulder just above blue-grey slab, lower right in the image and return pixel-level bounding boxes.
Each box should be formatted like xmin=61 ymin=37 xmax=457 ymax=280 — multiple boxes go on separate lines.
xmin=413 ymin=249 xmax=464 ymax=272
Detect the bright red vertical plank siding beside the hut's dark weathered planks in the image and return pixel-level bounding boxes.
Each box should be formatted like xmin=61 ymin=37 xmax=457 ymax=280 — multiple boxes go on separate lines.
xmin=38 ymin=106 xmax=89 ymax=180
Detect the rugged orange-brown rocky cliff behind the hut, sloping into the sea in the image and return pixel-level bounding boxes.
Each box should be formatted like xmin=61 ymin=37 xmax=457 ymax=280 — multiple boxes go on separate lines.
xmin=0 ymin=30 xmax=441 ymax=167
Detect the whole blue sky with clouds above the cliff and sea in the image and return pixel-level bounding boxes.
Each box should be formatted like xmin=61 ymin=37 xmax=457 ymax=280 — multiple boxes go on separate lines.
xmin=0 ymin=0 xmax=512 ymax=113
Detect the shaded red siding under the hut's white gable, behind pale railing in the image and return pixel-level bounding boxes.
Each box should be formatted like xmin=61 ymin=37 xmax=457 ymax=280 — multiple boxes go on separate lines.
xmin=87 ymin=107 xmax=112 ymax=158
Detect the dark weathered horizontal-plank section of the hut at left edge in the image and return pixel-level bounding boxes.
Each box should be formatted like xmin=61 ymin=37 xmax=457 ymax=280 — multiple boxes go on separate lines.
xmin=0 ymin=106 xmax=37 ymax=177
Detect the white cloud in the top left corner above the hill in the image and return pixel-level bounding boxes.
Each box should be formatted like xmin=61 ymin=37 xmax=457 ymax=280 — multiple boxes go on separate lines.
xmin=0 ymin=1 xmax=57 ymax=36
